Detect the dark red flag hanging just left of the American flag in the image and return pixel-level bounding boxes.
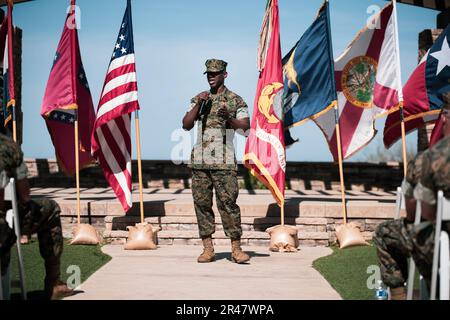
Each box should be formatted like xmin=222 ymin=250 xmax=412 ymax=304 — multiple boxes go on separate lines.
xmin=41 ymin=0 xmax=95 ymax=174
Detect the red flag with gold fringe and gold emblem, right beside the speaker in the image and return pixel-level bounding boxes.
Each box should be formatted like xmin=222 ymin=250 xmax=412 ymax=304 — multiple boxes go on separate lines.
xmin=244 ymin=0 xmax=286 ymax=206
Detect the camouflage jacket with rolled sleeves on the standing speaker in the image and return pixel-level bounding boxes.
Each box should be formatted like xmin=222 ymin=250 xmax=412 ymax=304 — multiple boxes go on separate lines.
xmin=189 ymin=87 xmax=249 ymax=171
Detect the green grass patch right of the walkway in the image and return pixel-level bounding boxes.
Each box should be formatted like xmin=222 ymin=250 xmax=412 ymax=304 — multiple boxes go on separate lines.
xmin=313 ymin=245 xmax=378 ymax=300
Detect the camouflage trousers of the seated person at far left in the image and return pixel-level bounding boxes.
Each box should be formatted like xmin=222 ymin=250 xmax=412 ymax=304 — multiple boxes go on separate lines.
xmin=0 ymin=199 xmax=63 ymax=271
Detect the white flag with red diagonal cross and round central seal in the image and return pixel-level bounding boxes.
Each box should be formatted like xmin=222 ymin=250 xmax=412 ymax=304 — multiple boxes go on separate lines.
xmin=314 ymin=3 xmax=402 ymax=161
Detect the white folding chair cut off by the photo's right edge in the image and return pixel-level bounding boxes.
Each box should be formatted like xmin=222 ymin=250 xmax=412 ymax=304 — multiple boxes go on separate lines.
xmin=430 ymin=190 xmax=450 ymax=300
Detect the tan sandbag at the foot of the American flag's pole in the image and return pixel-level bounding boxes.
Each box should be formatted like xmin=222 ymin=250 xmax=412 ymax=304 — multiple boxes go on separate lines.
xmin=124 ymin=223 xmax=159 ymax=250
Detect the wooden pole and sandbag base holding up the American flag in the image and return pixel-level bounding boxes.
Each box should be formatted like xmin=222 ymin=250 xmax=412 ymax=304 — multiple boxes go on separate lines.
xmin=124 ymin=111 xmax=160 ymax=250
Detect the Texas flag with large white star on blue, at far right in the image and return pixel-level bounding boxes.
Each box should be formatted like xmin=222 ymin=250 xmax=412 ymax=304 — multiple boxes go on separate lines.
xmin=384 ymin=25 xmax=450 ymax=148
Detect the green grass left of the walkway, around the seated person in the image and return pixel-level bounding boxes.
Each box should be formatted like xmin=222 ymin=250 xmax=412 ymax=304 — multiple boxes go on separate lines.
xmin=11 ymin=238 xmax=111 ymax=299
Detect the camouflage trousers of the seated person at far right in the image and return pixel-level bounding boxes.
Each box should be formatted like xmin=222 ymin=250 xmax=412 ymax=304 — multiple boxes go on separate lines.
xmin=373 ymin=219 xmax=434 ymax=288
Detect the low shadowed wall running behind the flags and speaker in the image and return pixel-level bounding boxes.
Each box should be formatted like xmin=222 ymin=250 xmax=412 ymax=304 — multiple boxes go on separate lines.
xmin=26 ymin=159 xmax=403 ymax=191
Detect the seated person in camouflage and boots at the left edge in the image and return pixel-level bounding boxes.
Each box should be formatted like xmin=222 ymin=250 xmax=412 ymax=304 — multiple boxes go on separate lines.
xmin=0 ymin=134 xmax=73 ymax=299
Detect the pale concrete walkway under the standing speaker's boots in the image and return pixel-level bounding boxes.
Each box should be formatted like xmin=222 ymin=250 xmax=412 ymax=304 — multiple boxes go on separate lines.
xmin=69 ymin=245 xmax=341 ymax=300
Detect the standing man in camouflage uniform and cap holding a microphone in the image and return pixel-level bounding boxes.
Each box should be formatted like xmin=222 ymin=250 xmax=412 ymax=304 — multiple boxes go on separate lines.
xmin=183 ymin=59 xmax=253 ymax=262
